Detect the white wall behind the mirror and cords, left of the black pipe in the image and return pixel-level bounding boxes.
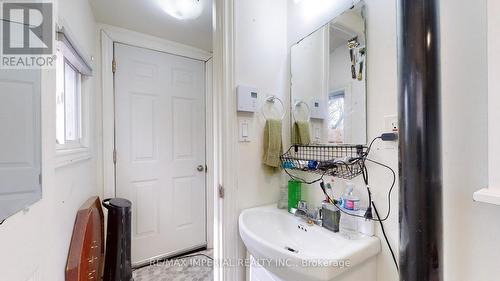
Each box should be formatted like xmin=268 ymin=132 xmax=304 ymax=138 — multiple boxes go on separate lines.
xmin=288 ymin=0 xmax=399 ymax=281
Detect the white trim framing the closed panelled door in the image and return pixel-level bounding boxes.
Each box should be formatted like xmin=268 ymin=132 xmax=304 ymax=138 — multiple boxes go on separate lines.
xmin=98 ymin=24 xmax=216 ymax=248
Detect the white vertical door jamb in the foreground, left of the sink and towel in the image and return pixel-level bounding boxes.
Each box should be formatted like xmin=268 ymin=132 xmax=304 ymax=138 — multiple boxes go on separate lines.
xmin=214 ymin=0 xmax=242 ymax=281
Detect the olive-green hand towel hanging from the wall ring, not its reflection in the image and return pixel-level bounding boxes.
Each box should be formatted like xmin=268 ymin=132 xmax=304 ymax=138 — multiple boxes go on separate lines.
xmin=263 ymin=120 xmax=283 ymax=168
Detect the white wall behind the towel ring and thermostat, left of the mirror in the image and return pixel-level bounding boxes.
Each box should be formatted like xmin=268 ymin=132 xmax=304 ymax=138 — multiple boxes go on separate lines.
xmin=234 ymin=0 xmax=289 ymax=280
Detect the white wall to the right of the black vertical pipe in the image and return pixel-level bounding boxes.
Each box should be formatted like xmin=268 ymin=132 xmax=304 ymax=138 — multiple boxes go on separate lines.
xmin=441 ymin=0 xmax=500 ymax=281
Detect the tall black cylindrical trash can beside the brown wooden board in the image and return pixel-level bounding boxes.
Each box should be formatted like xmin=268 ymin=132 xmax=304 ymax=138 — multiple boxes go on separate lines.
xmin=102 ymin=198 xmax=133 ymax=281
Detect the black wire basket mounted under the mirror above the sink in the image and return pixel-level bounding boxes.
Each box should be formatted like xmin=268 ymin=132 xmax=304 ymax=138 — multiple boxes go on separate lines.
xmin=281 ymin=145 xmax=367 ymax=180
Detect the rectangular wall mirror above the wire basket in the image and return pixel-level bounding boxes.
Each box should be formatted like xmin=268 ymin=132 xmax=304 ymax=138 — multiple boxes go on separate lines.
xmin=290 ymin=2 xmax=367 ymax=145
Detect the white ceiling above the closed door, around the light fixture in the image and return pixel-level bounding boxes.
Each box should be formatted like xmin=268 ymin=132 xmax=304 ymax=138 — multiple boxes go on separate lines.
xmin=89 ymin=0 xmax=212 ymax=51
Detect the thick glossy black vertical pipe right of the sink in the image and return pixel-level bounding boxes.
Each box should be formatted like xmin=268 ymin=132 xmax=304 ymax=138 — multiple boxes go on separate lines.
xmin=398 ymin=0 xmax=443 ymax=281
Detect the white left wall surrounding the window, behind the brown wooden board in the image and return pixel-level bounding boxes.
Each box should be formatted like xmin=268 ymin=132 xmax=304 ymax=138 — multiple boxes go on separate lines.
xmin=0 ymin=0 xmax=100 ymax=281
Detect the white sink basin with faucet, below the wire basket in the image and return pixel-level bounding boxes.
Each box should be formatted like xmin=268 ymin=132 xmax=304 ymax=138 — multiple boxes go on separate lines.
xmin=239 ymin=205 xmax=381 ymax=281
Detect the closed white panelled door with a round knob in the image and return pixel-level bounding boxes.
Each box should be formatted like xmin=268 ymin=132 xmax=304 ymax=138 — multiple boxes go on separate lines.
xmin=115 ymin=44 xmax=206 ymax=264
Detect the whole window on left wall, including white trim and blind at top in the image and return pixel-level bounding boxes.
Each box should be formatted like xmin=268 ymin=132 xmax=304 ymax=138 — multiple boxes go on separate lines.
xmin=55 ymin=29 xmax=92 ymax=167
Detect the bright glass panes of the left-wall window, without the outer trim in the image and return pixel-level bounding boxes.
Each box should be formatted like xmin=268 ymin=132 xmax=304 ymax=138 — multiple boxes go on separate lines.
xmin=56 ymin=55 xmax=83 ymax=149
